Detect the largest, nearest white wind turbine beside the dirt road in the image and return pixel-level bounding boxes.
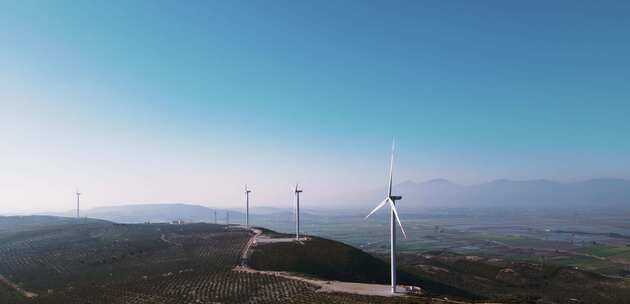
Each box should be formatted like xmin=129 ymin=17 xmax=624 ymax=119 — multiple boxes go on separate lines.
xmin=365 ymin=141 xmax=407 ymax=293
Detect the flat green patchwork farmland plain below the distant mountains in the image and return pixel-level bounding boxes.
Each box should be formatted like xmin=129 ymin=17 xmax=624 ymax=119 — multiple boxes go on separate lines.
xmin=256 ymin=206 xmax=630 ymax=279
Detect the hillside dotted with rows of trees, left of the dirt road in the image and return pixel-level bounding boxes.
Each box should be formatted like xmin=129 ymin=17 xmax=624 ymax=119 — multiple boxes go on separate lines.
xmin=0 ymin=218 xmax=444 ymax=304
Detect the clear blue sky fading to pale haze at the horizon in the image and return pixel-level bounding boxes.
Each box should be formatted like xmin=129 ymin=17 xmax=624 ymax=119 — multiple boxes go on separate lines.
xmin=0 ymin=0 xmax=630 ymax=213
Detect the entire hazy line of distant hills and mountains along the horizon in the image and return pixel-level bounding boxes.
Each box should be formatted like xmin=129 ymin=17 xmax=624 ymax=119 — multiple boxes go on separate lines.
xmin=40 ymin=179 xmax=630 ymax=224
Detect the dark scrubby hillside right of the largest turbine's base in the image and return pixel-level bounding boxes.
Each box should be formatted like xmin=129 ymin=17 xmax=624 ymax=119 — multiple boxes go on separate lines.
xmin=400 ymin=251 xmax=630 ymax=304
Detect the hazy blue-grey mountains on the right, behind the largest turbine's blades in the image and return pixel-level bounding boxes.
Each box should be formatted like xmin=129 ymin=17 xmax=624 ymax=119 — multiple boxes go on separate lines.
xmin=348 ymin=179 xmax=630 ymax=211
